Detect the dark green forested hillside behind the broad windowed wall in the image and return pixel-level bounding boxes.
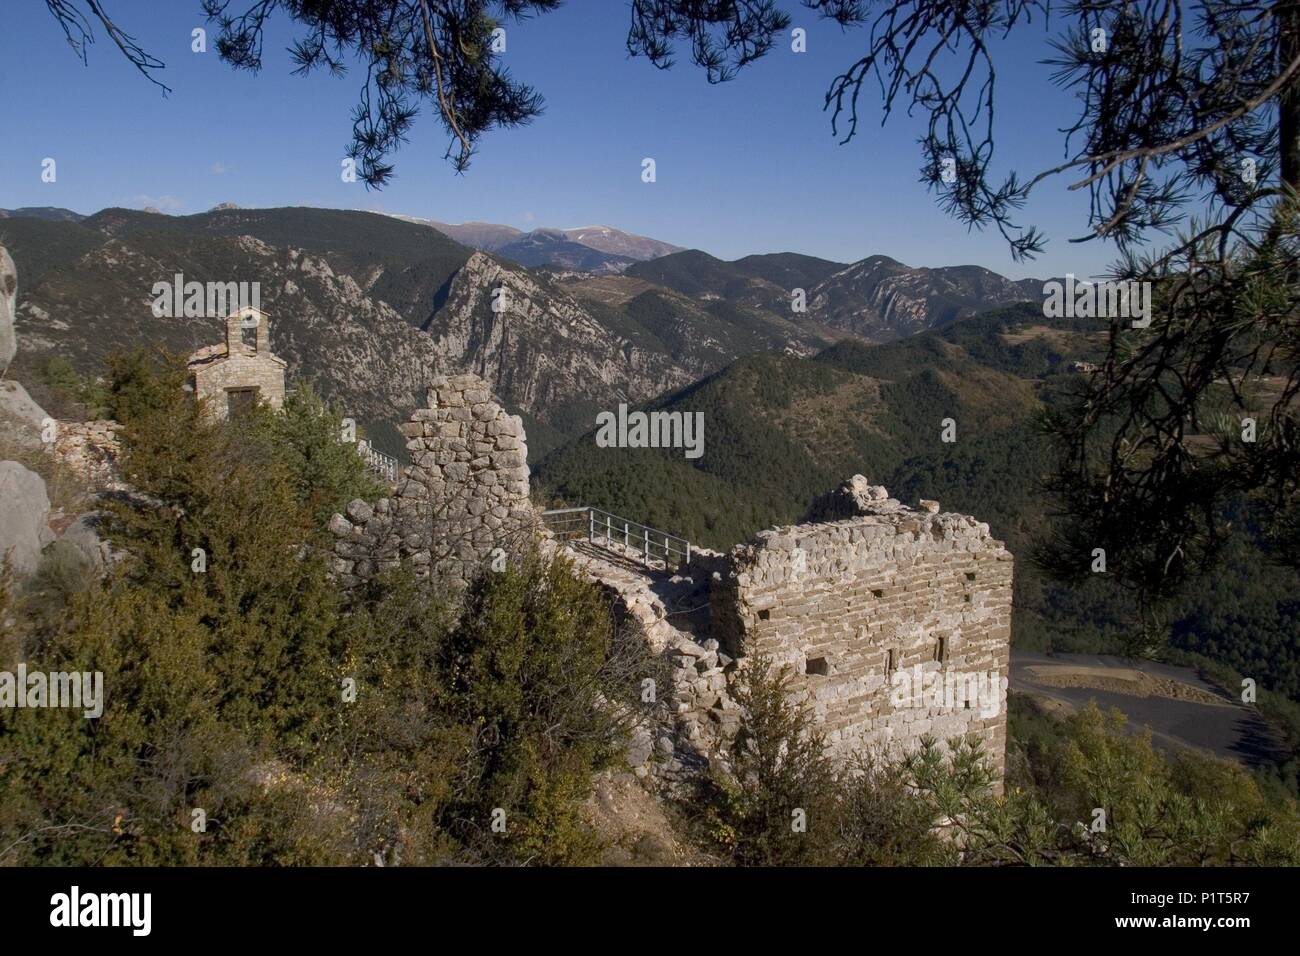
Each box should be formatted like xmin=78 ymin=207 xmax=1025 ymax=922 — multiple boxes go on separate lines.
xmin=537 ymin=306 xmax=1300 ymax=698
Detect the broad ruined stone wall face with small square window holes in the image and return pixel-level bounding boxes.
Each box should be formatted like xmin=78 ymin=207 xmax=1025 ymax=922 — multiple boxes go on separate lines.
xmin=710 ymin=476 xmax=1013 ymax=777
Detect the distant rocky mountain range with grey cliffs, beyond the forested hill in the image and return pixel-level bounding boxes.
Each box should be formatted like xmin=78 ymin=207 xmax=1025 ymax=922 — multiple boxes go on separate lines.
xmin=0 ymin=204 xmax=1036 ymax=450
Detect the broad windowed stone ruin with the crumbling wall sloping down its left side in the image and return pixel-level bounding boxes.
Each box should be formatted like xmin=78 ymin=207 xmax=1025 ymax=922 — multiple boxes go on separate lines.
xmin=571 ymin=476 xmax=1011 ymax=784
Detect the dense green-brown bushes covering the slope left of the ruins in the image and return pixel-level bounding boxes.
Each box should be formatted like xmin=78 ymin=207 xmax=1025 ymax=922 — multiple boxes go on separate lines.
xmin=0 ymin=351 xmax=637 ymax=865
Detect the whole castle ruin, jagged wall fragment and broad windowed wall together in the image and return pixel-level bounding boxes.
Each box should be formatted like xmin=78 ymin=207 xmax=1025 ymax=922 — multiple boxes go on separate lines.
xmin=330 ymin=375 xmax=1013 ymax=783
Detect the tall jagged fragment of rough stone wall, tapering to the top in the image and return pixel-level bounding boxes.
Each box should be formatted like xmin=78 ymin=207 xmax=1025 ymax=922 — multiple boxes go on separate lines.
xmin=329 ymin=375 xmax=537 ymax=587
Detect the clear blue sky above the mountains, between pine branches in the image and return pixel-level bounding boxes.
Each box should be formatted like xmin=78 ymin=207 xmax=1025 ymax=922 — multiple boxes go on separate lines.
xmin=0 ymin=0 xmax=1114 ymax=277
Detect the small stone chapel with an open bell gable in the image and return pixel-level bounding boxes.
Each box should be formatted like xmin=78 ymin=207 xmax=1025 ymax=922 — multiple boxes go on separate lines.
xmin=186 ymin=307 xmax=287 ymax=419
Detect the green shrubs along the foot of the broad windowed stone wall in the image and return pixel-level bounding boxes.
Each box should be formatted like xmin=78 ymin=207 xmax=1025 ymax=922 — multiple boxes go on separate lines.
xmin=696 ymin=658 xmax=1300 ymax=866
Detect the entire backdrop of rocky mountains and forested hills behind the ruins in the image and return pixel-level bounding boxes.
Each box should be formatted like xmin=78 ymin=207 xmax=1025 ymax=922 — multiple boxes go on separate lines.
xmin=0 ymin=207 xmax=1300 ymax=712
